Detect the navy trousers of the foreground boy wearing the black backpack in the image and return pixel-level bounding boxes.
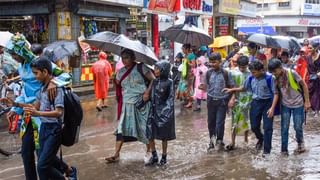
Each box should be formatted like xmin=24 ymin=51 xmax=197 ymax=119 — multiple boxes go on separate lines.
xmin=37 ymin=123 xmax=65 ymax=180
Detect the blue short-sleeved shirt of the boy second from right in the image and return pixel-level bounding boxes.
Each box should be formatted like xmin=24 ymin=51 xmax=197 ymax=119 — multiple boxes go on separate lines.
xmin=244 ymin=74 xmax=277 ymax=100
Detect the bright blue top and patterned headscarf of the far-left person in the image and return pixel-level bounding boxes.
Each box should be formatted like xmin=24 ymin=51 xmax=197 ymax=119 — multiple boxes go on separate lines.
xmin=6 ymin=35 xmax=71 ymax=149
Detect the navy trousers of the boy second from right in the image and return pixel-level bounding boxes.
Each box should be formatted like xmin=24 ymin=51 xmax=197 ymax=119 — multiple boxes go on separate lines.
xmin=250 ymin=99 xmax=273 ymax=154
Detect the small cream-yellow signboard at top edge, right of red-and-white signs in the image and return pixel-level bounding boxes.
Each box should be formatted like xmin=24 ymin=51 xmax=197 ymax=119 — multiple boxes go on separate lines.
xmin=219 ymin=0 xmax=240 ymax=15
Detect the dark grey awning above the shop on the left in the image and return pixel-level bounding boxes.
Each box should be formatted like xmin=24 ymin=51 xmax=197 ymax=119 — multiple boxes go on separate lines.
xmin=76 ymin=3 xmax=130 ymax=18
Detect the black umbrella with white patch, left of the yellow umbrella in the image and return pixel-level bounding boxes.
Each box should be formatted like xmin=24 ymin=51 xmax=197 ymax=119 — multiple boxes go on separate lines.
xmin=163 ymin=24 xmax=212 ymax=47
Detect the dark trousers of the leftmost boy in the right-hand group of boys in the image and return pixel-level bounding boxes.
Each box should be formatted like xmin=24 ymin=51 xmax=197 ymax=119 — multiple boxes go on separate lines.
xmin=207 ymin=96 xmax=228 ymax=141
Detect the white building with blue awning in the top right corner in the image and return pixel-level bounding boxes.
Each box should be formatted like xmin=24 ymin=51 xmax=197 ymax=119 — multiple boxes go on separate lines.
xmin=236 ymin=0 xmax=320 ymax=38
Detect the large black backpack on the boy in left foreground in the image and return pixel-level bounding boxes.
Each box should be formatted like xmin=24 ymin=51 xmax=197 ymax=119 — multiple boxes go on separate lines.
xmin=61 ymin=87 xmax=83 ymax=146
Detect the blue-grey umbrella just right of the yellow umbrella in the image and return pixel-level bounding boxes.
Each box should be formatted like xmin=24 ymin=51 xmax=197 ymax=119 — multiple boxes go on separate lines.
xmin=247 ymin=33 xmax=281 ymax=48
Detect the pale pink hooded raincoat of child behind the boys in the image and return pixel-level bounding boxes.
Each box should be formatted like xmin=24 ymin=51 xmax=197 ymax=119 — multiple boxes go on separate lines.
xmin=194 ymin=64 xmax=208 ymax=99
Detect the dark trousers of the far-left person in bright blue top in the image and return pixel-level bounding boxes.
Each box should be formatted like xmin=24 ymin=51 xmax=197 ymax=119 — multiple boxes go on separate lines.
xmin=21 ymin=122 xmax=38 ymax=180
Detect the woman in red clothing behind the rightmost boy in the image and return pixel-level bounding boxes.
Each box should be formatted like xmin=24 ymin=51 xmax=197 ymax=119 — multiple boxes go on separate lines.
xmin=295 ymin=46 xmax=309 ymax=84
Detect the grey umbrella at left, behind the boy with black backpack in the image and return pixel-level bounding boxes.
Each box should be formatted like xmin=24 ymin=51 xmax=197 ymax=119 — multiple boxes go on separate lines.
xmin=43 ymin=40 xmax=80 ymax=62
